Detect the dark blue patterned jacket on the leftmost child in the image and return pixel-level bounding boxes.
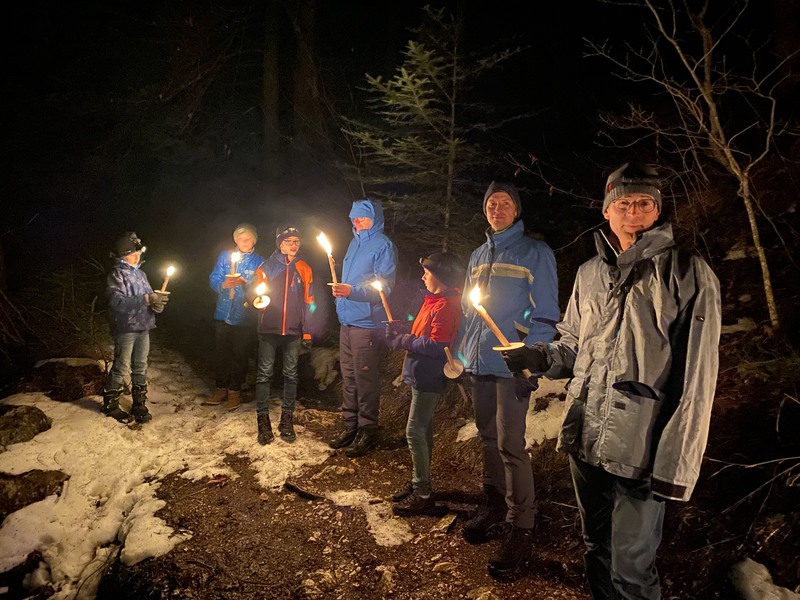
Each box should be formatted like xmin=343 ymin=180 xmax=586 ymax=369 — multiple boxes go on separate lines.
xmin=106 ymin=258 xmax=156 ymax=335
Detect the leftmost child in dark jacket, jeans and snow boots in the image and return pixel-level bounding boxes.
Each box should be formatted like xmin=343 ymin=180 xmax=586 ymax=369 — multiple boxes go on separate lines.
xmin=103 ymin=231 xmax=169 ymax=423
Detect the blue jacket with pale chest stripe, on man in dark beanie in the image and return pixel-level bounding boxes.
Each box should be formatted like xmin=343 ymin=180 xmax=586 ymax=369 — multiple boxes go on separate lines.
xmin=456 ymin=221 xmax=561 ymax=377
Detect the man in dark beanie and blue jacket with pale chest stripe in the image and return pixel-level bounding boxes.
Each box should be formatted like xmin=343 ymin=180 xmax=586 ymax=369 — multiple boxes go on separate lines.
xmin=457 ymin=182 xmax=560 ymax=575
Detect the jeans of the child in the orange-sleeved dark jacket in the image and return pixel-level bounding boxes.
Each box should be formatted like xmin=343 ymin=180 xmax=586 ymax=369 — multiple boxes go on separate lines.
xmin=256 ymin=333 xmax=301 ymax=413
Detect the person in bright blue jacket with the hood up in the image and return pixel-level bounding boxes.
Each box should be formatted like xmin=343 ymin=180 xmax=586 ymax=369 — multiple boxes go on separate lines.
xmin=328 ymin=198 xmax=397 ymax=458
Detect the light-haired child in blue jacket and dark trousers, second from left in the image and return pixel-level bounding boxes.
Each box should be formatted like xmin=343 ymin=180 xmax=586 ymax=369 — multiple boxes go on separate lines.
xmin=203 ymin=223 xmax=264 ymax=410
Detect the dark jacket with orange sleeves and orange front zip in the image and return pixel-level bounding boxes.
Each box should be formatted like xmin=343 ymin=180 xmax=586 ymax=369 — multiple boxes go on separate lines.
xmin=254 ymin=250 xmax=314 ymax=339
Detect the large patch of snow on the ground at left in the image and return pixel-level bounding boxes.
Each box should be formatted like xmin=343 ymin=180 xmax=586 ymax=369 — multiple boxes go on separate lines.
xmin=0 ymin=347 xmax=332 ymax=600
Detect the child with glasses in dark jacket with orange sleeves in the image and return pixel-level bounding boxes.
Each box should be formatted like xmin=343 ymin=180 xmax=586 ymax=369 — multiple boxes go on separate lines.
xmin=254 ymin=226 xmax=314 ymax=445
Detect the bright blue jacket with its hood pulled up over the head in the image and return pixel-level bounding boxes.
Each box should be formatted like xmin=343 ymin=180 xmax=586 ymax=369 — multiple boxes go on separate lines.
xmin=336 ymin=198 xmax=397 ymax=329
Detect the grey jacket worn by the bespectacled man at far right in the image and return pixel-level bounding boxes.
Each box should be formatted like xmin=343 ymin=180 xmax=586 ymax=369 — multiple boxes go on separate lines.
xmin=546 ymin=224 xmax=721 ymax=501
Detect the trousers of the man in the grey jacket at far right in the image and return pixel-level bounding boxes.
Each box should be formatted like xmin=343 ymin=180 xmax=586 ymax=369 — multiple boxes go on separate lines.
xmin=569 ymin=456 xmax=664 ymax=600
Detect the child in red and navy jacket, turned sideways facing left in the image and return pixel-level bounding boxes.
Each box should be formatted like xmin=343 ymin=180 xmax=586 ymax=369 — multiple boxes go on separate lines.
xmin=386 ymin=252 xmax=465 ymax=516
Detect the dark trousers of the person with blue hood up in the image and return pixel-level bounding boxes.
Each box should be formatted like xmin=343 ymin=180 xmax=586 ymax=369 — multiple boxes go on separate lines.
xmin=339 ymin=325 xmax=385 ymax=429
